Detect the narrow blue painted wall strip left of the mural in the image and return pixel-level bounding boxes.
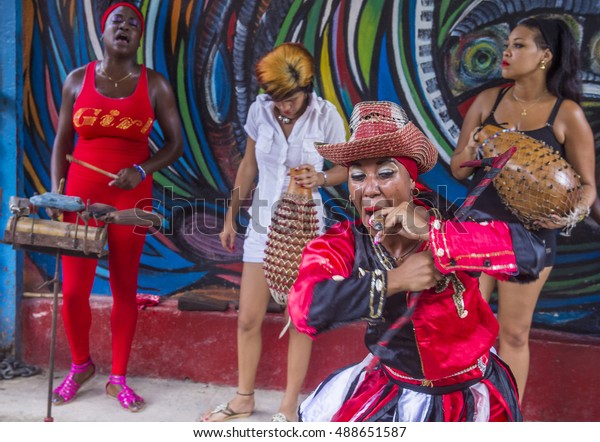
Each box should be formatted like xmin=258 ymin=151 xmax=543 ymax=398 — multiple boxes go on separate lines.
xmin=0 ymin=1 xmax=23 ymax=351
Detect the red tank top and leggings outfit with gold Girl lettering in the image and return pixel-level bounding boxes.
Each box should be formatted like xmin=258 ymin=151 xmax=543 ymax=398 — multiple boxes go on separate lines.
xmin=62 ymin=62 xmax=154 ymax=375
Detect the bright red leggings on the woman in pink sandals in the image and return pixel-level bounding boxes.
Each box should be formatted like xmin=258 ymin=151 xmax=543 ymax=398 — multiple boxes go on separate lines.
xmin=62 ymin=174 xmax=152 ymax=376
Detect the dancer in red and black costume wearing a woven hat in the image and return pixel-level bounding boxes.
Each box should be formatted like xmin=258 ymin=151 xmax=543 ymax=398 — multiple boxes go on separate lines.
xmin=288 ymin=102 xmax=540 ymax=422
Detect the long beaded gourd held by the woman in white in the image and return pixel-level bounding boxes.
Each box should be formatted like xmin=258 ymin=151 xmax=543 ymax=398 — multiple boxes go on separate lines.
xmin=263 ymin=169 xmax=319 ymax=305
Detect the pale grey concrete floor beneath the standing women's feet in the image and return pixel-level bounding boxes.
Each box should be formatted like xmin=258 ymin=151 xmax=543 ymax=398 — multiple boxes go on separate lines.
xmin=0 ymin=372 xmax=298 ymax=424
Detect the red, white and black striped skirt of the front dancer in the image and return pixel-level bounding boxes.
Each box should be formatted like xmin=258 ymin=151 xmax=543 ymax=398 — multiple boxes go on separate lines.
xmin=299 ymin=353 xmax=523 ymax=422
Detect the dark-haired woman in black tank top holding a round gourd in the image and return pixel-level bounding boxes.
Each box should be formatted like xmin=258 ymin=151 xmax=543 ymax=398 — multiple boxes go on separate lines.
xmin=451 ymin=17 xmax=596 ymax=401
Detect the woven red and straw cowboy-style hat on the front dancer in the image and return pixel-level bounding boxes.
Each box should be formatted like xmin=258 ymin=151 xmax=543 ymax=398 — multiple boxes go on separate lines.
xmin=315 ymin=101 xmax=438 ymax=179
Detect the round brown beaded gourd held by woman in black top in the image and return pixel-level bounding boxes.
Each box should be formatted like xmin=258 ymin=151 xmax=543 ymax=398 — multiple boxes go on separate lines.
xmin=479 ymin=125 xmax=584 ymax=230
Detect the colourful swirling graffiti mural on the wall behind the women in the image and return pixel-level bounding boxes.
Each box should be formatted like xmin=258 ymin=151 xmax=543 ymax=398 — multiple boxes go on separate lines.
xmin=23 ymin=0 xmax=600 ymax=335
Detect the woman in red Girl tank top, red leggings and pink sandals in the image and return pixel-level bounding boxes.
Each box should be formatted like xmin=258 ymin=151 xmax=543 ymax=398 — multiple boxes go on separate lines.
xmin=51 ymin=2 xmax=183 ymax=411
